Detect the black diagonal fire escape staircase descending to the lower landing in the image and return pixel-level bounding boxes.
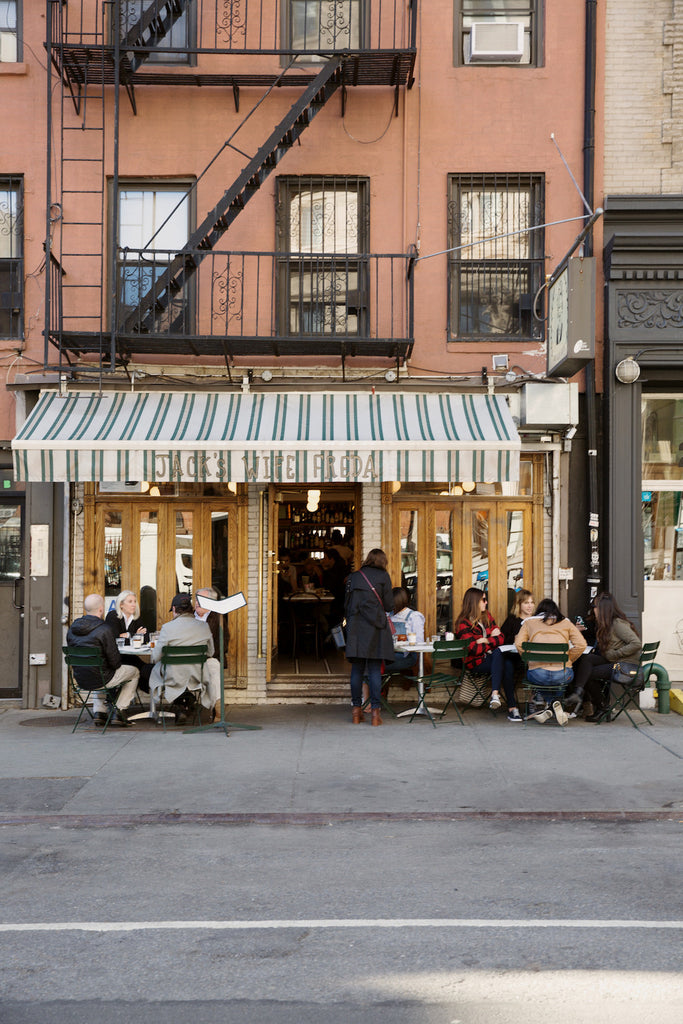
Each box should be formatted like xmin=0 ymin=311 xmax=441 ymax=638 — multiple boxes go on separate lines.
xmin=119 ymin=57 xmax=343 ymax=335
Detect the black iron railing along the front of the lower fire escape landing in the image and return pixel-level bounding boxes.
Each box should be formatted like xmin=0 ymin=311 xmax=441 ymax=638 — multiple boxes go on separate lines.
xmin=116 ymin=249 xmax=413 ymax=353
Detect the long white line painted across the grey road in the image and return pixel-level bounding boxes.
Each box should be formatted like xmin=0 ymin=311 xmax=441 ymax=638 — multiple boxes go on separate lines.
xmin=0 ymin=918 xmax=683 ymax=933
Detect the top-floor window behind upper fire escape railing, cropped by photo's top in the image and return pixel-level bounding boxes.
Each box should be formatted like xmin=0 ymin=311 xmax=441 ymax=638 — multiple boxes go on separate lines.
xmin=284 ymin=0 xmax=366 ymax=60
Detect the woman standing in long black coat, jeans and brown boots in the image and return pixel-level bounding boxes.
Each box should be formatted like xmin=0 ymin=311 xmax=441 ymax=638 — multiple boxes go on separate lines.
xmin=344 ymin=548 xmax=394 ymax=725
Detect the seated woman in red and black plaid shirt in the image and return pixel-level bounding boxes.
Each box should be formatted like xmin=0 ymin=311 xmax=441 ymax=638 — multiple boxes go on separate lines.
xmin=456 ymin=587 xmax=522 ymax=722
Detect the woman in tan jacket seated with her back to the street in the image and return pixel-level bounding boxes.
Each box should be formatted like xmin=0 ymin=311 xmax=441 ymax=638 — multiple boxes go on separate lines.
xmin=515 ymin=598 xmax=586 ymax=725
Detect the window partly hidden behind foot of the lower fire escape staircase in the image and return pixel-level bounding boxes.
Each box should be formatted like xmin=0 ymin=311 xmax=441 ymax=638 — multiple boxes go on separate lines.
xmin=118 ymin=182 xmax=194 ymax=334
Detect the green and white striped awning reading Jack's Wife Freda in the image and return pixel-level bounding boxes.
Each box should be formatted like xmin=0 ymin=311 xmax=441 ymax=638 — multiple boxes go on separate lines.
xmin=12 ymin=391 xmax=519 ymax=483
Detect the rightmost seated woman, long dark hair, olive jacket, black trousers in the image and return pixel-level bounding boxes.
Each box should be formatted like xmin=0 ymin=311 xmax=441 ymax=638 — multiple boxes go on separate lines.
xmin=565 ymin=592 xmax=643 ymax=722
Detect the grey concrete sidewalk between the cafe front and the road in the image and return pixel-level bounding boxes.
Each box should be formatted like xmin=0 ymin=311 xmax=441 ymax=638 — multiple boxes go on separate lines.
xmin=0 ymin=705 xmax=683 ymax=824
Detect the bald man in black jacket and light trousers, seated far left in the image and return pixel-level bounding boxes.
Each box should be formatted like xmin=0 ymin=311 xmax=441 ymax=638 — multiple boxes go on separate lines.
xmin=67 ymin=594 xmax=139 ymax=725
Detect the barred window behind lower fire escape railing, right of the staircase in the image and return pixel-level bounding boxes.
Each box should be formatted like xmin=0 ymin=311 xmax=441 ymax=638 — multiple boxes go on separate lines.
xmin=278 ymin=177 xmax=370 ymax=337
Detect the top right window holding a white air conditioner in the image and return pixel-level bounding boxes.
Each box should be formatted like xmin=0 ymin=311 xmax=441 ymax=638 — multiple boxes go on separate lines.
xmin=454 ymin=0 xmax=543 ymax=68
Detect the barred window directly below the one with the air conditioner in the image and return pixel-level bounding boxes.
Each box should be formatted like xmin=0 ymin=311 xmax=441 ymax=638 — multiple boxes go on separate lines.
xmin=449 ymin=174 xmax=545 ymax=340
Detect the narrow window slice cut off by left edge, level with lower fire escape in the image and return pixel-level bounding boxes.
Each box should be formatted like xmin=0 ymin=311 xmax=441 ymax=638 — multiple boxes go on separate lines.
xmin=0 ymin=177 xmax=24 ymax=339
